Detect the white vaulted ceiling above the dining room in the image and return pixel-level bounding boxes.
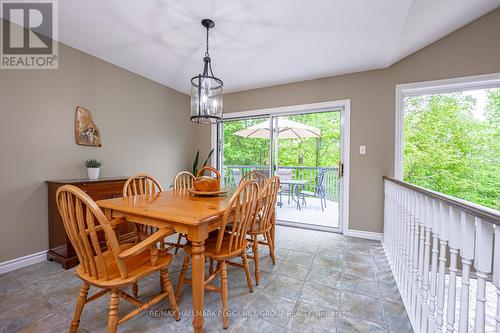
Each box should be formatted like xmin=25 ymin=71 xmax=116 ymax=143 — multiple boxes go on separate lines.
xmin=33 ymin=0 xmax=500 ymax=93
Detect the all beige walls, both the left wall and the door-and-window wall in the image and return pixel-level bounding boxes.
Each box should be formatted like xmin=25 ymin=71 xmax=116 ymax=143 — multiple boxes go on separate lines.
xmin=0 ymin=9 xmax=500 ymax=262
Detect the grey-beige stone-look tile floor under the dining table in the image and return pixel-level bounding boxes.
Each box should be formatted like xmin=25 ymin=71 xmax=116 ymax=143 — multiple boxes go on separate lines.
xmin=0 ymin=227 xmax=412 ymax=333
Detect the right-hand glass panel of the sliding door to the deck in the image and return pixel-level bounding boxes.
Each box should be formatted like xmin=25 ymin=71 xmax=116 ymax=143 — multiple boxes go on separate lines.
xmin=274 ymin=111 xmax=340 ymax=229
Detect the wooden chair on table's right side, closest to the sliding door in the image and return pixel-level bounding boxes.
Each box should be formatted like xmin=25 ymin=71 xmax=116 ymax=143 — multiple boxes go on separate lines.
xmin=248 ymin=176 xmax=280 ymax=285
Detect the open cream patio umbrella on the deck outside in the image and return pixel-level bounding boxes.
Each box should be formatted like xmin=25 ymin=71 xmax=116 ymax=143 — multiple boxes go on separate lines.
xmin=234 ymin=118 xmax=321 ymax=139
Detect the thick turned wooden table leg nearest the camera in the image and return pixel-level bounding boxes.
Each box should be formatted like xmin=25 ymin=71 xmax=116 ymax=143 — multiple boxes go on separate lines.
xmin=191 ymin=241 xmax=205 ymax=333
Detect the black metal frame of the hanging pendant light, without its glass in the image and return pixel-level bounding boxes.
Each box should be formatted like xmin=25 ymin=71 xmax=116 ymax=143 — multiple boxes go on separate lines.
xmin=191 ymin=19 xmax=224 ymax=124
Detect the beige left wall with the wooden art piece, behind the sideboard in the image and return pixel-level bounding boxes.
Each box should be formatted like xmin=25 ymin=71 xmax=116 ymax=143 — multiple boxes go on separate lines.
xmin=0 ymin=40 xmax=198 ymax=262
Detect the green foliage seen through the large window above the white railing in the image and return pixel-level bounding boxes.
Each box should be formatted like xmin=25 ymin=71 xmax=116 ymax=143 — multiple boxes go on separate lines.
xmin=404 ymin=89 xmax=500 ymax=209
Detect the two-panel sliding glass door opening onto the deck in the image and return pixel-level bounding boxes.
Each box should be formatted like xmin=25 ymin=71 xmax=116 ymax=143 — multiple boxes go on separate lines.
xmin=218 ymin=110 xmax=342 ymax=231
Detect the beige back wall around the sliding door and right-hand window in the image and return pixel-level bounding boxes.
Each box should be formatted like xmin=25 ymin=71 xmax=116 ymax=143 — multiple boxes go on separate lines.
xmin=198 ymin=9 xmax=500 ymax=232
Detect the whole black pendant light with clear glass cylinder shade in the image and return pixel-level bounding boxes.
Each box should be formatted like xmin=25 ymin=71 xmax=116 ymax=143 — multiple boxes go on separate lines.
xmin=191 ymin=19 xmax=223 ymax=124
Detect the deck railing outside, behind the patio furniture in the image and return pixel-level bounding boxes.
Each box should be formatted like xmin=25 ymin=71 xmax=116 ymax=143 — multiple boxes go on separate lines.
xmin=223 ymin=165 xmax=339 ymax=202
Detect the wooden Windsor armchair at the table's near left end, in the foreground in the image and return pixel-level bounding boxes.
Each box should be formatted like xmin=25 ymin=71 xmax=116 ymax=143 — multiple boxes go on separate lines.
xmin=56 ymin=185 xmax=180 ymax=332
